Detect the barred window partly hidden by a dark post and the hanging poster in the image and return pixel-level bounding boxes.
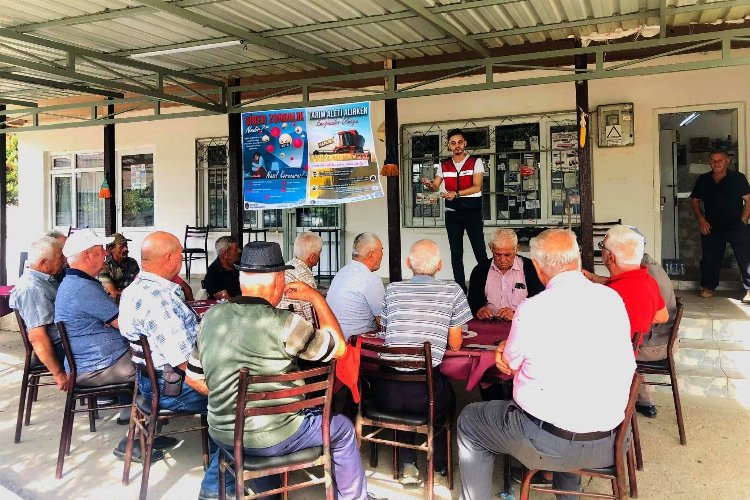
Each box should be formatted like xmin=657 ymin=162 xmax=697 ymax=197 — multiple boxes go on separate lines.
xmin=195 ymin=137 xmax=282 ymax=231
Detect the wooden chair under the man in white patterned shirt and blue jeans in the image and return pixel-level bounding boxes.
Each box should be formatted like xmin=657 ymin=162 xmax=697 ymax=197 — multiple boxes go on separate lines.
xmin=122 ymin=337 xmax=208 ymax=500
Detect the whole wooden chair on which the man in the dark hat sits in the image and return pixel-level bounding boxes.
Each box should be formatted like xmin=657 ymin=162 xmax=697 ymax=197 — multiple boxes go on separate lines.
xmin=219 ymin=360 xmax=336 ymax=500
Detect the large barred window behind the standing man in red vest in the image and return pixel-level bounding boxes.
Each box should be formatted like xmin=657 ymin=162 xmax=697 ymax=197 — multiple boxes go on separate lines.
xmin=401 ymin=113 xmax=580 ymax=227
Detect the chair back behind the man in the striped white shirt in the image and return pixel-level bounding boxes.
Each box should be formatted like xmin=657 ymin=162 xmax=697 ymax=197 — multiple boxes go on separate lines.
xmin=359 ymin=342 xmax=435 ymax=424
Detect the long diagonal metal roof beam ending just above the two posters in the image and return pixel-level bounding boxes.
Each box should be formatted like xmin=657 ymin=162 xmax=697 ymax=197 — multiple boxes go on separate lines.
xmin=138 ymin=0 xmax=350 ymax=73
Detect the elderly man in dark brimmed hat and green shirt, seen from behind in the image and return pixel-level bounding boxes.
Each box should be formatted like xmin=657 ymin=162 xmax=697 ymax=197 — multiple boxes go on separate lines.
xmin=188 ymin=241 xmax=368 ymax=500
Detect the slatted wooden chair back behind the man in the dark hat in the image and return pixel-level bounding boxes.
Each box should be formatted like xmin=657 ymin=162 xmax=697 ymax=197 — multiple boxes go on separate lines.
xmin=234 ymin=360 xmax=336 ymax=458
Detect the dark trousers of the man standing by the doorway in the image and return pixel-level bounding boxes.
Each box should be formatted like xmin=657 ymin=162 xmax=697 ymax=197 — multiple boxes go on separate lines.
xmin=701 ymin=224 xmax=750 ymax=291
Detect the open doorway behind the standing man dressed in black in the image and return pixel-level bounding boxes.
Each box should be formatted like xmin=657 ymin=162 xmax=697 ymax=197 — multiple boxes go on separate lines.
xmin=659 ymin=108 xmax=740 ymax=283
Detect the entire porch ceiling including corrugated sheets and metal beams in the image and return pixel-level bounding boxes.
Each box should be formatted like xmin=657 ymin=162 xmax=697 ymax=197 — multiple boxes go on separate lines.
xmin=0 ymin=0 xmax=750 ymax=129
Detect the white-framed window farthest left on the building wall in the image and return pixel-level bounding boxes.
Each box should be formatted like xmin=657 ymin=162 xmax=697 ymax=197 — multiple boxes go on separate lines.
xmin=50 ymin=152 xmax=104 ymax=228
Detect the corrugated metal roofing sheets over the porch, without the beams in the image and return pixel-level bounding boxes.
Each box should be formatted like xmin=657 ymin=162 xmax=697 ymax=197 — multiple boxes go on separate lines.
xmin=0 ymin=0 xmax=750 ymax=113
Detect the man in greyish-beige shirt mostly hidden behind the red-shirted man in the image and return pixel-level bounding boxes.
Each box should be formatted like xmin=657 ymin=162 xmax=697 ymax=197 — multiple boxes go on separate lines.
xmin=583 ymin=228 xmax=679 ymax=418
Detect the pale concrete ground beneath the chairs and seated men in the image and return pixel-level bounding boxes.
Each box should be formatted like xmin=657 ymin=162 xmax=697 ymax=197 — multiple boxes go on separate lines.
xmin=0 ymin=331 xmax=750 ymax=500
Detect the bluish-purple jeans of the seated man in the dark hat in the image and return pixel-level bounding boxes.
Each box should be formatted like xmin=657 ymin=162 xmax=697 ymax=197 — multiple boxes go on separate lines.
xmin=210 ymin=410 xmax=367 ymax=500
